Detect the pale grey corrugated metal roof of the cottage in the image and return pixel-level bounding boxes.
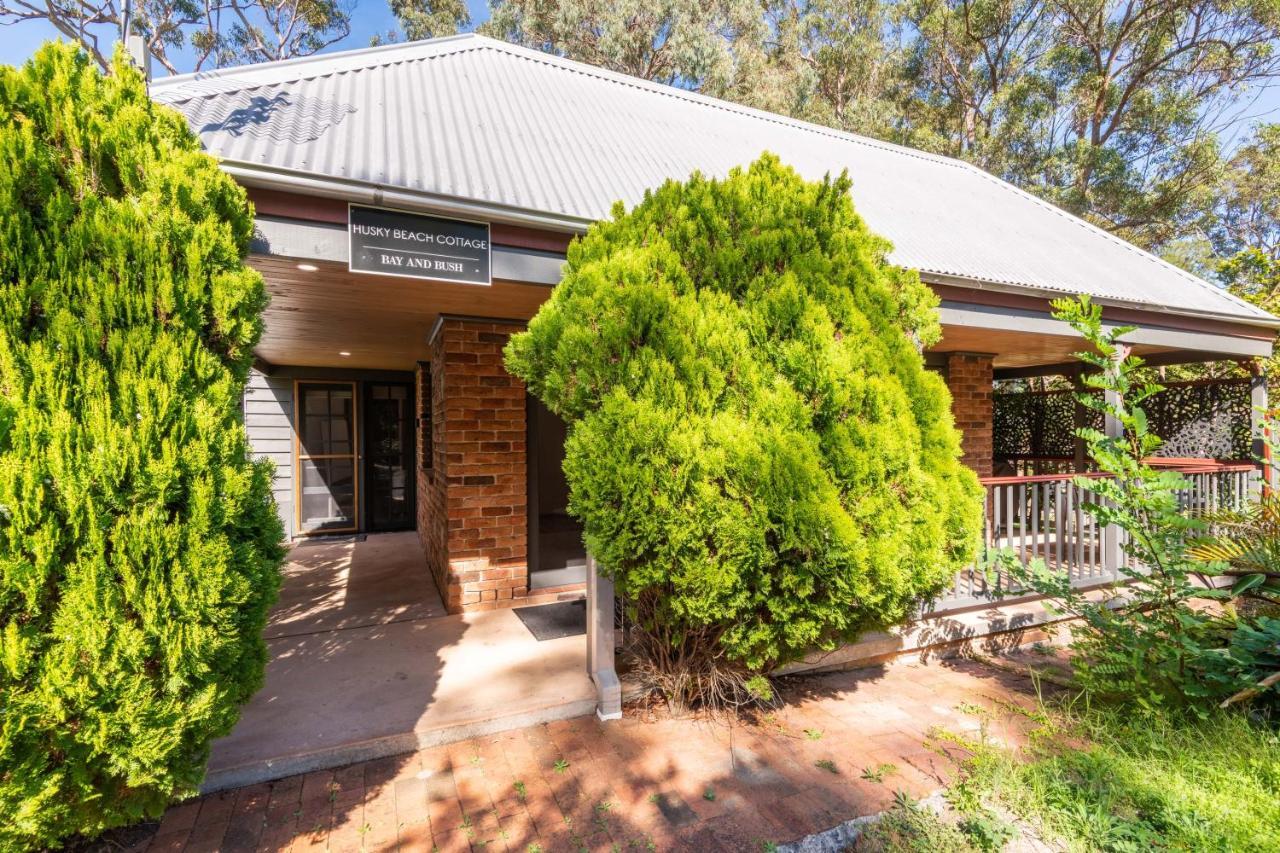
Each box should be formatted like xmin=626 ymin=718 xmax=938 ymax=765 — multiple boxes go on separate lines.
xmin=152 ymin=35 xmax=1271 ymax=321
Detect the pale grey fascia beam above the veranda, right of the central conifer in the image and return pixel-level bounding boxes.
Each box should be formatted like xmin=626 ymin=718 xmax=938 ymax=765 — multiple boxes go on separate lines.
xmin=938 ymin=300 xmax=1271 ymax=359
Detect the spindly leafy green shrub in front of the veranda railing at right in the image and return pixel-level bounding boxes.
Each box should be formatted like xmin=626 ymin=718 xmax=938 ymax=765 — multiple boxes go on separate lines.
xmin=1000 ymin=297 xmax=1280 ymax=711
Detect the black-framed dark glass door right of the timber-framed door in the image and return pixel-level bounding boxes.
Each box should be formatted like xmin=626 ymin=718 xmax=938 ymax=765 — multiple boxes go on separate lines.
xmin=365 ymin=382 xmax=416 ymax=530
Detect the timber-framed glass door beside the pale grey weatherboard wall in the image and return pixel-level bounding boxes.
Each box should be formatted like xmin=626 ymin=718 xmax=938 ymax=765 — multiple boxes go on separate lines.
xmin=294 ymin=382 xmax=358 ymax=533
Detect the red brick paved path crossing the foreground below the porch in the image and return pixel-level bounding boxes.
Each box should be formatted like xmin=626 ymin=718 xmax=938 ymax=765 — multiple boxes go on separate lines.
xmin=133 ymin=661 xmax=1032 ymax=853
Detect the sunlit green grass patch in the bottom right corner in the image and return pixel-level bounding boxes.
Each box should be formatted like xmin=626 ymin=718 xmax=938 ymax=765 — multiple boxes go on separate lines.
xmin=948 ymin=707 xmax=1280 ymax=852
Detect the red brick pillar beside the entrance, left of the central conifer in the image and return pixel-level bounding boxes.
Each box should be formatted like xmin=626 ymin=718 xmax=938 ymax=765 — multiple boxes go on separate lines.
xmin=419 ymin=318 xmax=529 ymax=613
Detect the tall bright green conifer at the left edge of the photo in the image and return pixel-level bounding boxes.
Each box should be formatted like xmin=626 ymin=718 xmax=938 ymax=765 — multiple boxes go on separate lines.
xmin=0 ymin=45 xmax=283 ymax=849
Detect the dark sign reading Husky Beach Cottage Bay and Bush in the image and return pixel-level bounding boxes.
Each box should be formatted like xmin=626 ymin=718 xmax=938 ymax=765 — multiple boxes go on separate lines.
xmin=347 ymin=205 xmax=490 ymax=284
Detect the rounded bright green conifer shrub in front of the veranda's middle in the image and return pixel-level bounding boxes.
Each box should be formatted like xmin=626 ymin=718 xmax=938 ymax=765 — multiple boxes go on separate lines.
xmin=507 ymin=155 xmax=980 ymax=702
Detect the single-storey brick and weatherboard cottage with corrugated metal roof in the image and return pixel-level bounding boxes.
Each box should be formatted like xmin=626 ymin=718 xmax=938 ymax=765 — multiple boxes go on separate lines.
xmin=151 ymin=35 xmax=1280 ymax=722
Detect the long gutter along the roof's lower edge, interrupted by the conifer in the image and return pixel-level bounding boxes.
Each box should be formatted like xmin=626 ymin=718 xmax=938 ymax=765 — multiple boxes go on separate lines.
xmin=219 ymin=159 xmax=1280 ymax=330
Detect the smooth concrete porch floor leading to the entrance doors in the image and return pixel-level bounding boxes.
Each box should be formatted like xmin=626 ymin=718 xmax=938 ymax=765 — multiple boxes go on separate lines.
xmin=205 ymin=533 xmax=595 ymax=790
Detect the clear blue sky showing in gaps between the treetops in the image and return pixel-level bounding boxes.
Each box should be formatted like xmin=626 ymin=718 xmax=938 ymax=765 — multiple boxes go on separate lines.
xmin=0 ymin=0 xmax=1280 ymax=146
